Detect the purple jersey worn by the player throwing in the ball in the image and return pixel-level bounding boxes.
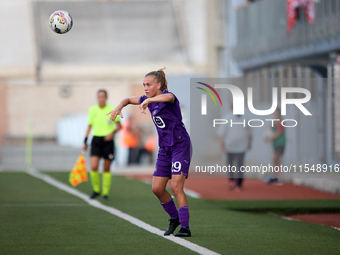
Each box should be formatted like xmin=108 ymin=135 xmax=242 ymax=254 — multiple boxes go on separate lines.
xmin=139 ymin=90 xmax=190 ymax=147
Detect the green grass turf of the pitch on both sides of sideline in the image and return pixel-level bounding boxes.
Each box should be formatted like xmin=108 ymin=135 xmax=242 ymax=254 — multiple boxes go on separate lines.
xmin=0 ymin=173 xmax=340 ymax=254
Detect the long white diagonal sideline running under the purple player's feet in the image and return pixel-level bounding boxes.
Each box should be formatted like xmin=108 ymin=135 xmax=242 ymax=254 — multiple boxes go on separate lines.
xmin=27 ymin=169 xmax=219 ymax=255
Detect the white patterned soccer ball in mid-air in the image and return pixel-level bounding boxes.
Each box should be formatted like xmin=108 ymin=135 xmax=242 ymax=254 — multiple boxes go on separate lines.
xmin=49 ymin=10 xmax=73 ymax=34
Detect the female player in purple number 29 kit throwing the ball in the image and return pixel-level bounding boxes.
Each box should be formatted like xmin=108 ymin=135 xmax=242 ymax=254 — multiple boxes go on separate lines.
xmin=108 ymin=69 xmax=191 ymax=237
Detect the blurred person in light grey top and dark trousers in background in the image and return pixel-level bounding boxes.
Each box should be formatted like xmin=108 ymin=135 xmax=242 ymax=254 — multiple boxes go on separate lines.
xmin=219 ymin=106 xmax=252 ymax=192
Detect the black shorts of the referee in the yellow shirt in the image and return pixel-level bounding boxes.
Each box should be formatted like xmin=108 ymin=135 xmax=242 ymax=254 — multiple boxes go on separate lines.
xmin=91 ymin=136 xmax=115 ymax=161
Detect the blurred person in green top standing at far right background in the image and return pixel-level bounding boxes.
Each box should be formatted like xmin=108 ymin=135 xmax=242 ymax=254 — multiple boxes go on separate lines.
xmin=265 ymin=108 xmax=286 ymax=184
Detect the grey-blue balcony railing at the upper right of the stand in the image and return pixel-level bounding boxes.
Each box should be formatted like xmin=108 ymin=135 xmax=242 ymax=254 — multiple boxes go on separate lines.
xmin=233 ymin=0 xmax=340 ymax=68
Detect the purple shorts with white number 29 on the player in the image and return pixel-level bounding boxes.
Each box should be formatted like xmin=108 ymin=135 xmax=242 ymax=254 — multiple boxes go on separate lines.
xmin=153 ymin=139 xmax=192 ymax=179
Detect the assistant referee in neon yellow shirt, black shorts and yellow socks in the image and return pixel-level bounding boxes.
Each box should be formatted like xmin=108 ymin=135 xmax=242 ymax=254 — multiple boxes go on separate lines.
xmin=83 ymin=89 xmax=122 ymax=200
